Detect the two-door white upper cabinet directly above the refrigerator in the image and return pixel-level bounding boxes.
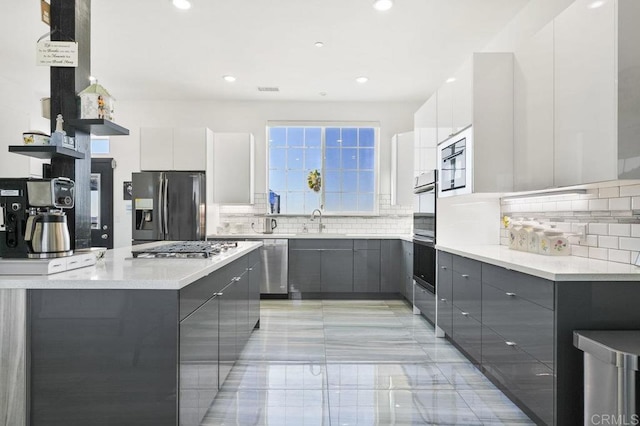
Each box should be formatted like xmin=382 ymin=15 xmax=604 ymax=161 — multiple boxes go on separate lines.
xmin=140 ymin=127 xmax=212 ymax=171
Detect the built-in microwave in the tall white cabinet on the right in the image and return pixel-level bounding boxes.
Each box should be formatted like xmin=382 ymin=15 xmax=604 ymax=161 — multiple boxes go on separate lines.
xmin=437 ymin=126 xmax=473 ymax=197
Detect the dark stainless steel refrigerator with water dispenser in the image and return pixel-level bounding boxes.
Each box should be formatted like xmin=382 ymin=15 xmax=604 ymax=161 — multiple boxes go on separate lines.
xmin=132 ymin=171 xmax=206 ymax=244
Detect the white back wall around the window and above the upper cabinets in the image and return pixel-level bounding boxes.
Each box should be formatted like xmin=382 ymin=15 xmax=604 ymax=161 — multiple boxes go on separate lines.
xmin=97 ymin=101 xmax=419 ymax=247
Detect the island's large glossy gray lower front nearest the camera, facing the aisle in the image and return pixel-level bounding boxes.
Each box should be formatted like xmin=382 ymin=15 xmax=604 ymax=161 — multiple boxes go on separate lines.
xmin=180 ymin=296 xmax=219 ymax=426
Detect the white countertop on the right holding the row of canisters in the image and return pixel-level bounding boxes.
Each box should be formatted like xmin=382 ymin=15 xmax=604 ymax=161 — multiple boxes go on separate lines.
xmin=436 ymin=244 xmax=640 ymax=281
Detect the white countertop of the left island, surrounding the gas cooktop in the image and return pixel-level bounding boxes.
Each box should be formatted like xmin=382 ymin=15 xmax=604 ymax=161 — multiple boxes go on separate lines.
xmin=0 ymin=241 xmax=262 ymax=290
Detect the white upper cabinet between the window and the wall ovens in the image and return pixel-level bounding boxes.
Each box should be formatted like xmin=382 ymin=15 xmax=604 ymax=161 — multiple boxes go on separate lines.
xmin=391 ymin=132 xmax=414 ymax=206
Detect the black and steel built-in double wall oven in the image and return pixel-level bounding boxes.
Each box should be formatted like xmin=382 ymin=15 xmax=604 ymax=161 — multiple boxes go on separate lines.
xmin=413 ymin=170 xmax=438 ymax=297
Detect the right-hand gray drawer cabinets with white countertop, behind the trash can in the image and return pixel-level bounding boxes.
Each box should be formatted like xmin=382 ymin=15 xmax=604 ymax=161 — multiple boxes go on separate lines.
xmin=436 ymin=245 xmax=640 ymax=425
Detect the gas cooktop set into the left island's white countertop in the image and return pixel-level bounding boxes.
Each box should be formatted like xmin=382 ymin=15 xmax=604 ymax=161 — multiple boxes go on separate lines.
xmin=131 ymin=241 xmax=238 ymax=259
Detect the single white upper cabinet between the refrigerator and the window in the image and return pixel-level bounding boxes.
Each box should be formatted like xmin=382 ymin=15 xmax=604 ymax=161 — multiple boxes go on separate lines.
xmin=213 ymin=133 xmax=255 ymax=204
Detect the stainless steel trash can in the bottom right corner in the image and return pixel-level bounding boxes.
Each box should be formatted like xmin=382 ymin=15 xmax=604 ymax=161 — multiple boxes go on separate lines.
xmin=573 ymin=330 xmax=640 ymax=425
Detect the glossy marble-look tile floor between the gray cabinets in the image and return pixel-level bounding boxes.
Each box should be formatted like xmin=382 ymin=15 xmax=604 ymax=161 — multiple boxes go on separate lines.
xmin=202 ymin=300 xmax=534 ymax=426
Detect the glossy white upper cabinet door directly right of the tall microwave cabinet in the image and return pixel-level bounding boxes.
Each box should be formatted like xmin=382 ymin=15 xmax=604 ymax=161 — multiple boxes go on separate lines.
xmin=513 ymin=22 xmax=554 ymax=191
